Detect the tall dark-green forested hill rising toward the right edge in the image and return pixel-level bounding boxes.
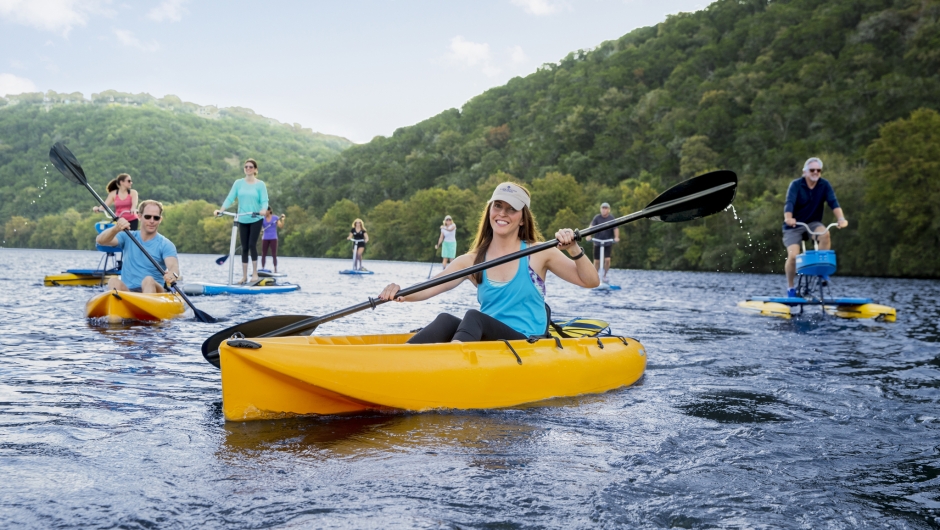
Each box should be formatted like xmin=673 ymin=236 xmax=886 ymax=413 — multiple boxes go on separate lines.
xmin=286 ymin=0 xmax=940 ymax=277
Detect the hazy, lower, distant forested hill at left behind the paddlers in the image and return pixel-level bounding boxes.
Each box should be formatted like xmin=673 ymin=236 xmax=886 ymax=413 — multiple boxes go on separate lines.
xmin=0 ymin=91 xmax=352 ymax=225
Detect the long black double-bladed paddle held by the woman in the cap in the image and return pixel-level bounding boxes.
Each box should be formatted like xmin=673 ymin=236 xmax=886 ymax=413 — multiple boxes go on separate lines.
xmin=202 ymin=170 xmax=738 ymax=368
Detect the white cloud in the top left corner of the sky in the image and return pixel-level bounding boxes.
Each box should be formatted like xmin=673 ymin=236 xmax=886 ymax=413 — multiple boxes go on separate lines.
xmin=0 ymin=0 xmax=106 ymax=37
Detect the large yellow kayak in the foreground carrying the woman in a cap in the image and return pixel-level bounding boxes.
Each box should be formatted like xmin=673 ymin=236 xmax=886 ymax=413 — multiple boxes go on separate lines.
xmin=219 ymin=334 xmax=646 ymax=421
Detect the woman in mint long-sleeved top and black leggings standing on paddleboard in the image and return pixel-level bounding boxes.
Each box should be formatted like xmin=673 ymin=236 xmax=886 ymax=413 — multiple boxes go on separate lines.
xmin=214 ymin=158 xmax=268 ymax=283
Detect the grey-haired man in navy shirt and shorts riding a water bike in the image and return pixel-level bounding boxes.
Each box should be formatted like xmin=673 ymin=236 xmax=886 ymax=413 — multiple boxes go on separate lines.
xmin=783 ymin=157 xmax=849 ymax=298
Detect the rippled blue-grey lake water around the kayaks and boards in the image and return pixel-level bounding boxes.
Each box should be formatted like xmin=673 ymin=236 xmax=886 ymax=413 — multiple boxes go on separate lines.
xmin=0 ymin=245 xmax=940 ymax=528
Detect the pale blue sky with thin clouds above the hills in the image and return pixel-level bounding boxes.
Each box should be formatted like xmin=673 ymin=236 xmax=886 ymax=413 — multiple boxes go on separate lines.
xmin=0 ymin=0 xmax=707 ymax=142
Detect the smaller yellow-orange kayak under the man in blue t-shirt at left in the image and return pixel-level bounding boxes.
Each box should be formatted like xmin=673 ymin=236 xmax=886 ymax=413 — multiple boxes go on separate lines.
xmin=85 ymin=290 xmax=186 ymax=322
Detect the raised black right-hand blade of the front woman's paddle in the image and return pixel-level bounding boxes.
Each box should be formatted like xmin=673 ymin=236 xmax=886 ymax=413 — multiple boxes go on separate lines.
xmin=646 ymin=169 xmax=738 ymax=223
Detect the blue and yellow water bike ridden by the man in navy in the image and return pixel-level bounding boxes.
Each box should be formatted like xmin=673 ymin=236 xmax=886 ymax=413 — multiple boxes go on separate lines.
xmin=738 ymin=222 xmax=897 ymax=322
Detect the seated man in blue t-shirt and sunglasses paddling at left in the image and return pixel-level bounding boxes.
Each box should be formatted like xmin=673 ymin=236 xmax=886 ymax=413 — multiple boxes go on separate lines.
xmin=95 ymin=201 xmax=180 ymax=293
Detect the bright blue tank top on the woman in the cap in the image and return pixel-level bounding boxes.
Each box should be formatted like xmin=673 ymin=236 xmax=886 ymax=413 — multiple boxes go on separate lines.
xmin=477 ymin=241 xmax=548 ymax=337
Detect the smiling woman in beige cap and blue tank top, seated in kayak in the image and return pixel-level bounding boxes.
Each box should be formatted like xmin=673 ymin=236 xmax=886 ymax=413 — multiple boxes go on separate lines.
xmin=379 ymin=182 xmax=600 ymax=344
